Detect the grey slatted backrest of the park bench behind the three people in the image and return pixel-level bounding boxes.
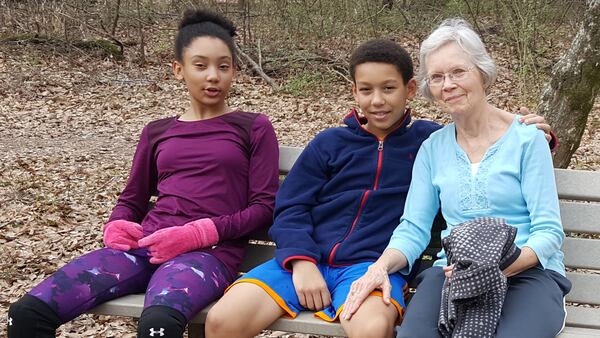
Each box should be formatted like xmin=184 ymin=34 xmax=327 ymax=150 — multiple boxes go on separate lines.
xmin=240 ymin=146 xmax=600 ymax=305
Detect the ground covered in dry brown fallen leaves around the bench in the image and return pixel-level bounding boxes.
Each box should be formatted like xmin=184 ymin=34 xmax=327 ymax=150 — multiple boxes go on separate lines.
xmin=0 ymin=38 xmax=600 ymax=337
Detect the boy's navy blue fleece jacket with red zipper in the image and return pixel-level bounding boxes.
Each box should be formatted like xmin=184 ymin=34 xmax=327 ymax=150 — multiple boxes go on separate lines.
xmin=269 ymin=110 xmax=441 ymax=270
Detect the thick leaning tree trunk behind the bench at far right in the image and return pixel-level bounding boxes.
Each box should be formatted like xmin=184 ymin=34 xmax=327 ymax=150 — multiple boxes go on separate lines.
xmin=538 ymin=0 xmax=600 ymax=168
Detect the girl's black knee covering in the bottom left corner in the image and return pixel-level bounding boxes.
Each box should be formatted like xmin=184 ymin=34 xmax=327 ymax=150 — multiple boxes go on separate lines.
xmin=7 ymin=295 xmax=62 ymax=338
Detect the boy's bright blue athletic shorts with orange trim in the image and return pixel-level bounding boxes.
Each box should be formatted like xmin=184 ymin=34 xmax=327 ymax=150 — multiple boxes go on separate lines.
xmin=230 ymin=259 xmax=408 ymax=322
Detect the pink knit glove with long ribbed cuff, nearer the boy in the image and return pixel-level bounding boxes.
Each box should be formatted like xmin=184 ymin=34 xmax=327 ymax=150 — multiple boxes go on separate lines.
xmin=138 ymin=218 xmax=219 ymax=264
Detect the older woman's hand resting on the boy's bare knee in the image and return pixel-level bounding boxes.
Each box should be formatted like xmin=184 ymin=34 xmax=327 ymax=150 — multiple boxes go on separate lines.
xmin=340 ymin=264 xmax=392 ymax=320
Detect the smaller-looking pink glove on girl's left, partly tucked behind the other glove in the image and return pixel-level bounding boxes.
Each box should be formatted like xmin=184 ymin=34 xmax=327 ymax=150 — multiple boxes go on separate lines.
xmin=103 ymin=219 xmax=144 ymax=251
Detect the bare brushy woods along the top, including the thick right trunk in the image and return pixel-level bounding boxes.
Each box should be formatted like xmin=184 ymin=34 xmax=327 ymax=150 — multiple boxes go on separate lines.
xmin=0 ymin=0 xmax=600 ymax=167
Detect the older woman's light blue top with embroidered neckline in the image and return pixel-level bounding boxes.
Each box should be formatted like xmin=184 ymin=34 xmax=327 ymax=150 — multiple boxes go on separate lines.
xmin=388 ymin=116 xmax=565 ymax=276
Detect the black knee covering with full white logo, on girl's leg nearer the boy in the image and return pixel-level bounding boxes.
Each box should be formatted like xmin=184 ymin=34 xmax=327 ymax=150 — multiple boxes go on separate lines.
xmin=138 ymin=305 xmax=187 ymax=338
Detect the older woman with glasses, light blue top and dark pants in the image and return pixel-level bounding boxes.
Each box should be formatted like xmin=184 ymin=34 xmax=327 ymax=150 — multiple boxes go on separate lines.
xmin=342 ymin=19 xmax=571 ymax=338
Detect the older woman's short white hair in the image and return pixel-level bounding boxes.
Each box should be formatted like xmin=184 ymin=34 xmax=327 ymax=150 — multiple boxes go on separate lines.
xmin=417 ymin=18 xmax=498 ymax=101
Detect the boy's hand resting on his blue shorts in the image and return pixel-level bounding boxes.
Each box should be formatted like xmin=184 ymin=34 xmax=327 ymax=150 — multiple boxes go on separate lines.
xmin=292 ymin=259 xmax=331 ymax=311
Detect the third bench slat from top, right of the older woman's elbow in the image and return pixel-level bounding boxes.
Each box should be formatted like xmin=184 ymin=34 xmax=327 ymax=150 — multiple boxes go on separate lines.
xmin=562 ymin=237 xmax=600 ymax=270
